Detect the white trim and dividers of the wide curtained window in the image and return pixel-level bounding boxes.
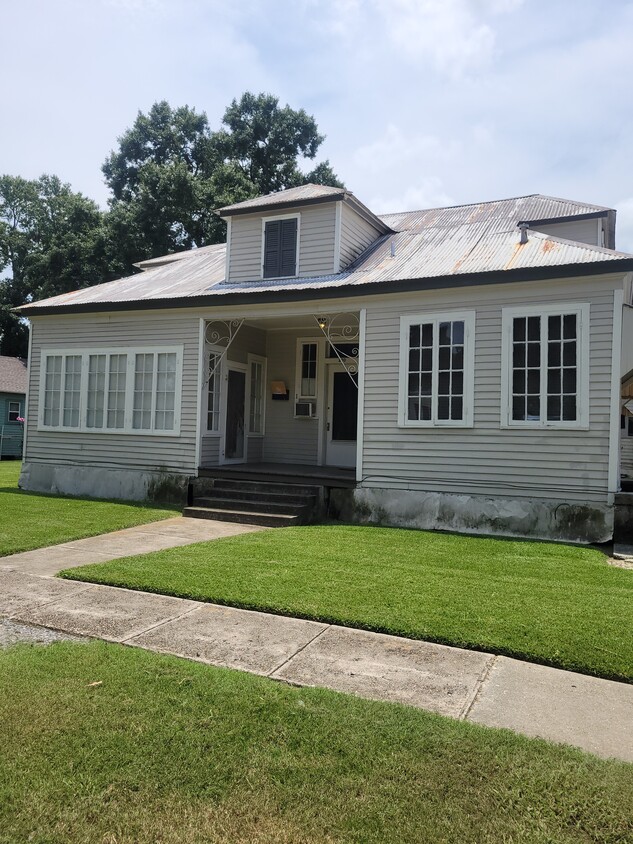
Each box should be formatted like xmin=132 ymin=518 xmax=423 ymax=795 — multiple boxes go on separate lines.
xmin=37 ymin=345 xmax=184 ymax=437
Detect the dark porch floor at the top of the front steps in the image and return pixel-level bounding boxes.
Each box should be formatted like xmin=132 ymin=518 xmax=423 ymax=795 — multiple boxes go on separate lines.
xmin=198 ymin=463 xmax=356 ymax=488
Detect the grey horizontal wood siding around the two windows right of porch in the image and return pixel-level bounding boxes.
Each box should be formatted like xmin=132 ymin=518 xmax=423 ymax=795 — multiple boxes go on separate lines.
xmin=363 ymin=276 xmax=622 ymax=502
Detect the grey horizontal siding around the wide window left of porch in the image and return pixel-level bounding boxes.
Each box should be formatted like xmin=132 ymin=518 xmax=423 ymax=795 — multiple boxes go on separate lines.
xmin=26 ymin=311 xmax=199 ymax=473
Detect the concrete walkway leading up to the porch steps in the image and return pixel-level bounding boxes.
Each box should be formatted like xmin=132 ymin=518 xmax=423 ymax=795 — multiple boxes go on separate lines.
xmin=0 ymin=516 xmax=266 ymax=576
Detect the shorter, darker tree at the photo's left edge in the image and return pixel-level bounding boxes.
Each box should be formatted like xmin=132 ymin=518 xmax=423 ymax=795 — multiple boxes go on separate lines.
xmin=0 ymin=175 xmax=114 ymax=356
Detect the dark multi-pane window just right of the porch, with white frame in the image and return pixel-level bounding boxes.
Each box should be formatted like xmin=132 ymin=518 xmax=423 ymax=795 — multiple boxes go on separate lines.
xmin=399 ymin=312 xmax=475 ymax=428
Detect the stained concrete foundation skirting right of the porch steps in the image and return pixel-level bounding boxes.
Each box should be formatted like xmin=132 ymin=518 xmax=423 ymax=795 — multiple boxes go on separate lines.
xmin=330 ymin=487 xmax=613 ymax=542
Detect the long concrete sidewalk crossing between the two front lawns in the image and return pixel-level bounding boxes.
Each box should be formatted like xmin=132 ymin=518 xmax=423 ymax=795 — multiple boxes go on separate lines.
xmin=0 ymin=569 xmax=633 ymax=762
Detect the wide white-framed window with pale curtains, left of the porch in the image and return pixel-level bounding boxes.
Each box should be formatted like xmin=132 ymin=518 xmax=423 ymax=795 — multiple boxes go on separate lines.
xmin=40 ymin=348 xmax=182 ymax=434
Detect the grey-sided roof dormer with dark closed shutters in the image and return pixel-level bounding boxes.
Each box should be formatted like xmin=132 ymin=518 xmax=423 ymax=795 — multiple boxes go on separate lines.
xmin=216 ymin=184 xmax=392 ymax=282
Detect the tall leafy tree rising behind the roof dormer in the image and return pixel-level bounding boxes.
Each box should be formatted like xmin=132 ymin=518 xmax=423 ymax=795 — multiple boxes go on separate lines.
xmin=103 ymin=93 xmax=342 ymax=272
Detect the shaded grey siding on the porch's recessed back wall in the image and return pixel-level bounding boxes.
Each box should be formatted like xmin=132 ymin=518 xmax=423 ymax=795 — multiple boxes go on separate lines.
xmin=263 ymin=331 xmax=323 ymax=465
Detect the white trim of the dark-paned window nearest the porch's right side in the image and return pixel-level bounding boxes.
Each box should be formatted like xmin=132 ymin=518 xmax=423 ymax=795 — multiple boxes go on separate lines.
xmin=398 ymin=311 xmax=475 ymax=428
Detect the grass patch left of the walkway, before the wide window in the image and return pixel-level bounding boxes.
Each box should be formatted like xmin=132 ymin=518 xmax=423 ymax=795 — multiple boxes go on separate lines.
xmin=0 ymin=460 xmax=174 ymax=557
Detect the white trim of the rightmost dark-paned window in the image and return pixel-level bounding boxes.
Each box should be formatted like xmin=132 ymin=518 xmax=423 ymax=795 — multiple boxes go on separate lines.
xmin=501 ymin=302 xmax=591 ymax=431
